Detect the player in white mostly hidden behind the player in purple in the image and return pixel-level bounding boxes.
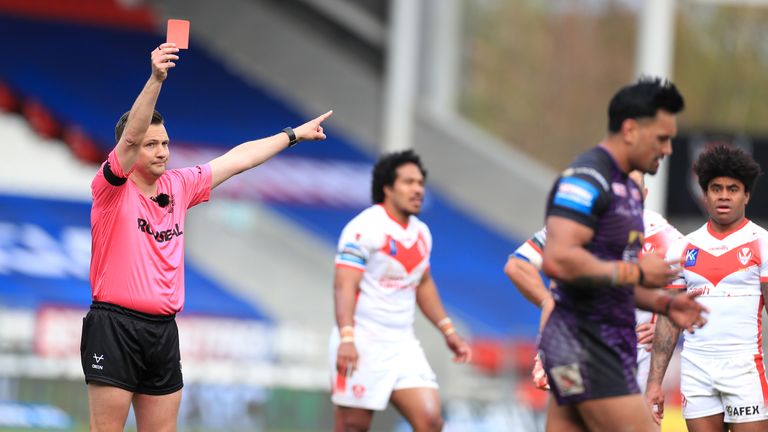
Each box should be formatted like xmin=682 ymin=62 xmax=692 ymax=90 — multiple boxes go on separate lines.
xmin=504 ymin=171 xmax=682 ymax=391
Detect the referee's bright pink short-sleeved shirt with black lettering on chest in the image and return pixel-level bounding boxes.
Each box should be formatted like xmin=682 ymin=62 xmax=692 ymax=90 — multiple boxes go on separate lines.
xmin=91 ymin=151 xmax=211 ymax=315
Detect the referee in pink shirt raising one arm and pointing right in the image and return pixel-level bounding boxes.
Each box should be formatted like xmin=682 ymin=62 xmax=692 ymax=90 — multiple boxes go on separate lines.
xmin=80 ymin=43 xmax=331 ymax=432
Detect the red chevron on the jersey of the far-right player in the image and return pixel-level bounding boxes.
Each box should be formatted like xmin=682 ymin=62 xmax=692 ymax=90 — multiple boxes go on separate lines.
xmin=685 ymin=240 xmax=760 ymax=286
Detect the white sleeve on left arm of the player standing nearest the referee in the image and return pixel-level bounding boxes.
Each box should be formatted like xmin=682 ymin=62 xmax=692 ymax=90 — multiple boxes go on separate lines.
xmin=335 ymin=214 xmax=380 ymax=270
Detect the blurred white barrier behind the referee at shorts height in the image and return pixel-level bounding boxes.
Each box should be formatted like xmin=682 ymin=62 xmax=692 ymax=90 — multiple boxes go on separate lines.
xmin=0 ymin=307 xmax=330 ymax=390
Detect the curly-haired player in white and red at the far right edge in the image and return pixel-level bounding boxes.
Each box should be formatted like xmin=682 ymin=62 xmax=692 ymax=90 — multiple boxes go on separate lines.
xmin=646 ymin=144 xmax=768 ymax=432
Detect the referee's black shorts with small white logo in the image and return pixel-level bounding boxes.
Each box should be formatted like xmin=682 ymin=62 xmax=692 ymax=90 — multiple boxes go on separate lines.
xmin=80 ymin=302 xmax=184 ymax=395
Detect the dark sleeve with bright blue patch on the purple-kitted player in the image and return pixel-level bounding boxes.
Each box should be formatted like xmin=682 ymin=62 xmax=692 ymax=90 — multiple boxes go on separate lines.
xmin=547 ymin=173 xmax=611 ymax=229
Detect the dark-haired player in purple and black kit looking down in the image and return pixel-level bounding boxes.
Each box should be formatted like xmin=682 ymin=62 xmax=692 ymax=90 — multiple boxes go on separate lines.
xmin=539 ymin=78 xmax=705 ymax=432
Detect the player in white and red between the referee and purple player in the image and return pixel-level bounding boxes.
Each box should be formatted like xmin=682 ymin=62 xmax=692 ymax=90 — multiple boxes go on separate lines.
xmin=329 ymin=150 xmax=470 ymax=431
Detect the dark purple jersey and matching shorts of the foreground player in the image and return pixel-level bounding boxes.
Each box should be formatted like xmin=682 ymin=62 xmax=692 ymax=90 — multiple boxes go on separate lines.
xmin=539 ymin=147 xmax=643 ymax=404
